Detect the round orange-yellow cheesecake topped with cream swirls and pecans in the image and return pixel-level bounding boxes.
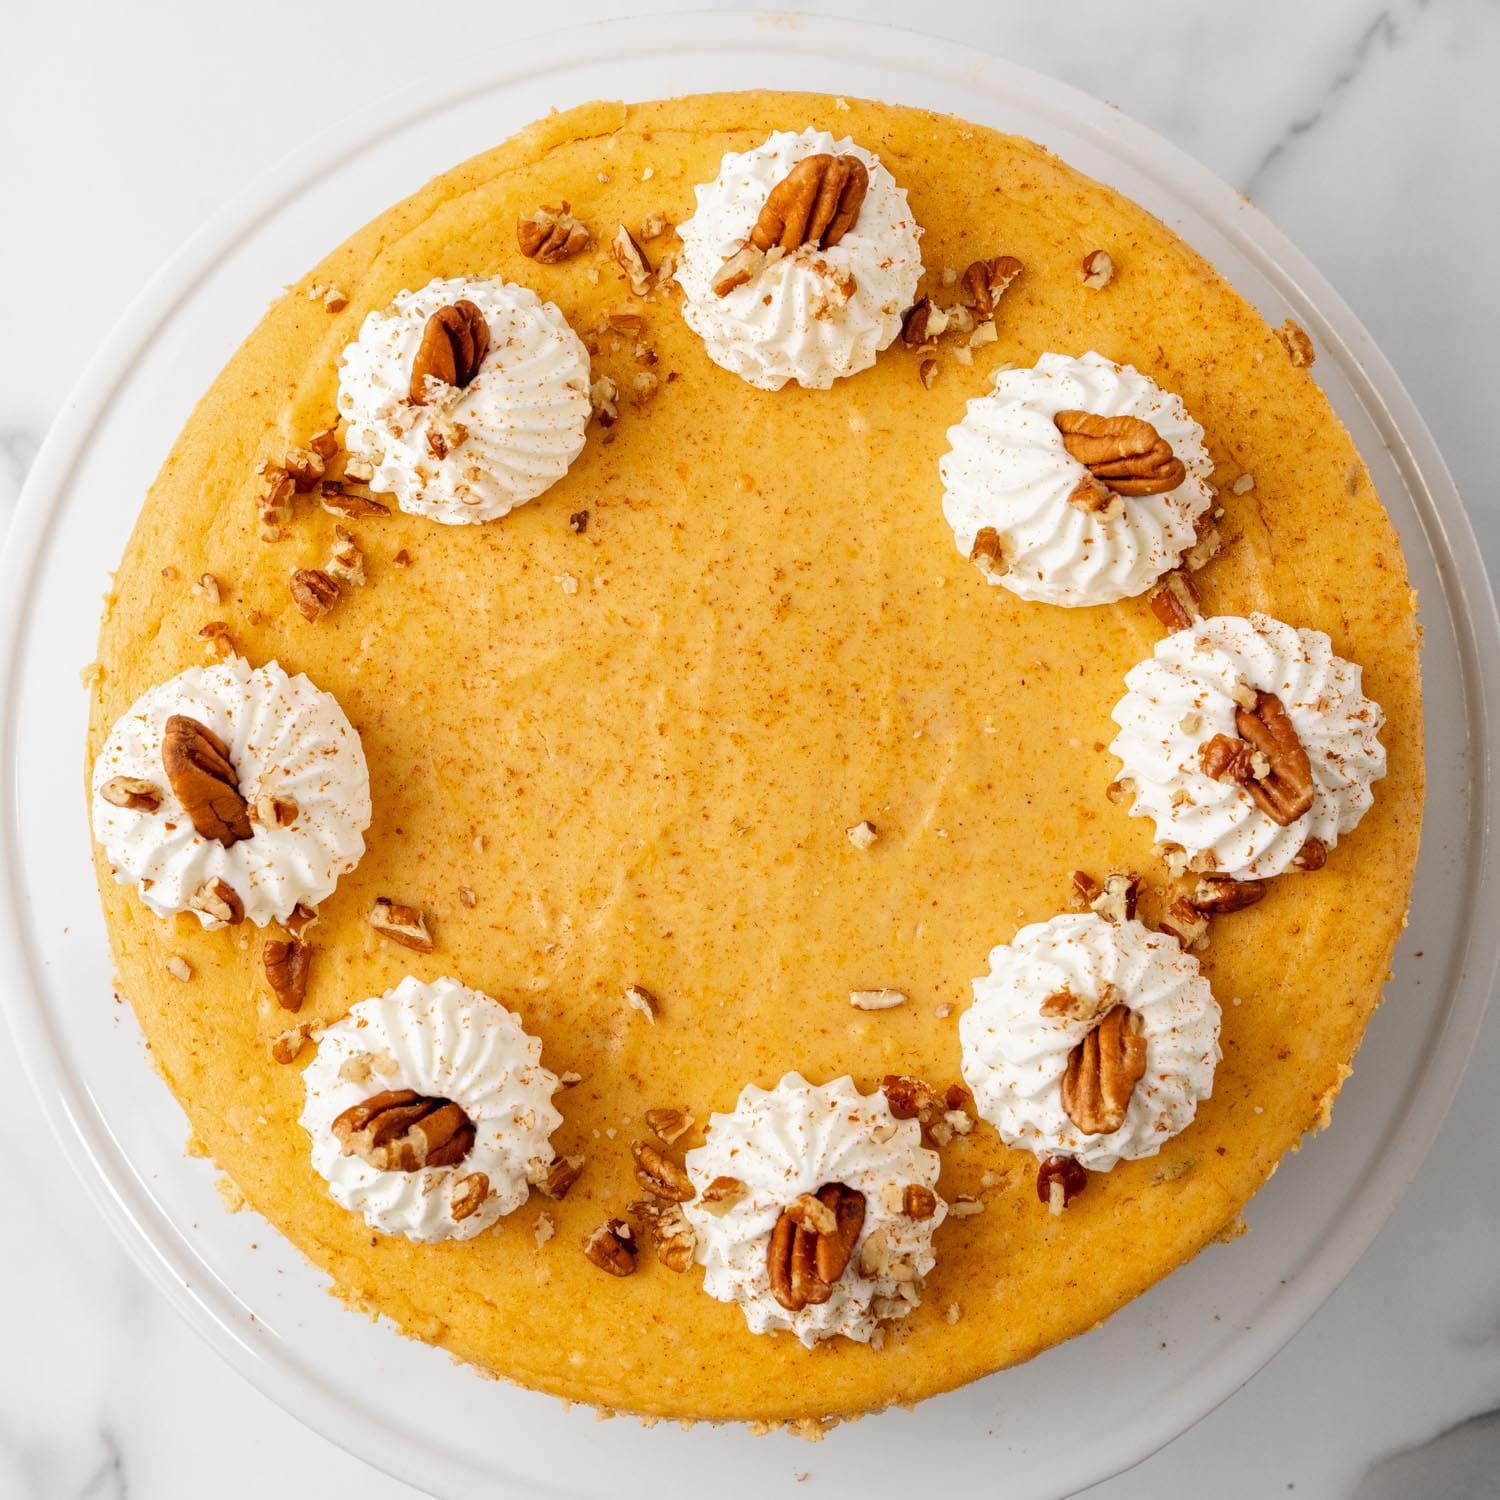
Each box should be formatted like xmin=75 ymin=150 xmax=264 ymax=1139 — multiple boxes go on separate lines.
xmin=89 ymin=93 xmax=1424 ymax=1422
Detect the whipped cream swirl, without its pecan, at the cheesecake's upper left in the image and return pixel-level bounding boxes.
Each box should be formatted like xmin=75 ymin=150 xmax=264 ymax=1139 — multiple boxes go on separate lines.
xmin=339 ymin=276 xmax=590 ymax=525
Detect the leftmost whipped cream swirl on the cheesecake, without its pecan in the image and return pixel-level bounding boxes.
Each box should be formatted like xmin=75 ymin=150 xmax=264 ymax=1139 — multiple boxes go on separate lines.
xmin=93 ymin=657 xmax=371 ymax=927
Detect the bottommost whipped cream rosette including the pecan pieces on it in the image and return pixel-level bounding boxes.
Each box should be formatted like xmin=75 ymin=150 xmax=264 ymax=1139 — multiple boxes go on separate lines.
xmin=683 ymin=1073 xmax=948 ymax=1349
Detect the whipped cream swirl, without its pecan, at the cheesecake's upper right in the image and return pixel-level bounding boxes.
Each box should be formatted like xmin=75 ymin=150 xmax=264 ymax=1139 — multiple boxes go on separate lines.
xmin=938 ymin=354 xmax=1214 ymax=605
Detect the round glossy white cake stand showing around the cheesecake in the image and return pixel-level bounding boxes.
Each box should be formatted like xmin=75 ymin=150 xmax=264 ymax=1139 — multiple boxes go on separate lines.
xmin=0 ymin=15 xmax=1500 ymax=1500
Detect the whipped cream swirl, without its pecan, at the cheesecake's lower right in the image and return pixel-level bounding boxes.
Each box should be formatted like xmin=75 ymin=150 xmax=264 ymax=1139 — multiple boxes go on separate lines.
xmin=959 ymin=912 xmax=1220 ymax=1172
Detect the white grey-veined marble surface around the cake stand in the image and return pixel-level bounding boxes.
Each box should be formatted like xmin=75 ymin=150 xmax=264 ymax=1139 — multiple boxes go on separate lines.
xmin=0 ymin=0 xmax=1500 ymax=1500
